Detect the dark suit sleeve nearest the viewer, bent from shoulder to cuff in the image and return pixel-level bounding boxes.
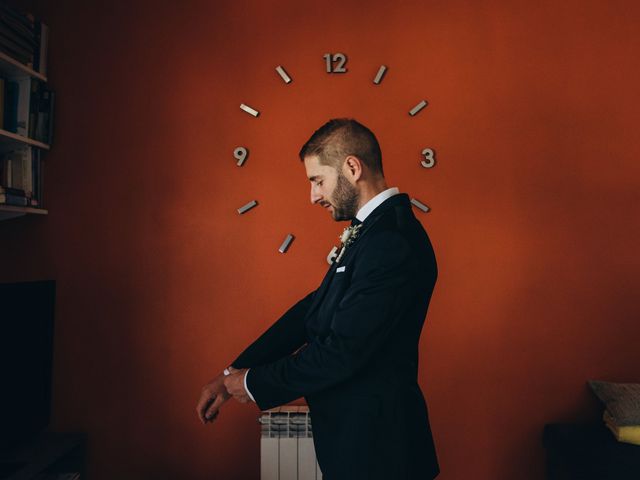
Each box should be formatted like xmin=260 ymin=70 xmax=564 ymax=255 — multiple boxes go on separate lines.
xmin=247 ymin=232 xmax=415 ymax=410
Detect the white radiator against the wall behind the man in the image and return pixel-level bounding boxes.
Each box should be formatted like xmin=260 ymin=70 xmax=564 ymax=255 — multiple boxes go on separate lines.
xmin=260 ymin=406 xmax=322 ymax=480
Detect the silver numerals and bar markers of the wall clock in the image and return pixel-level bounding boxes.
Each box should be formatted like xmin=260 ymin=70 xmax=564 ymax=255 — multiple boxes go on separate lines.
xmin=233 ymin=53 xmax=436 ymax=264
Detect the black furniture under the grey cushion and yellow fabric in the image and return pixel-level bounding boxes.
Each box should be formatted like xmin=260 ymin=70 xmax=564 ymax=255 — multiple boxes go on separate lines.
xmin=543 ymin=423 xmax=640 ymax=480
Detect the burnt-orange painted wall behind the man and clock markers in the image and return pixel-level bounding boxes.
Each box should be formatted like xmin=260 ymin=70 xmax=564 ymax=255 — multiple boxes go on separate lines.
xmin=0 ymin=0 xmax=640 ymax=480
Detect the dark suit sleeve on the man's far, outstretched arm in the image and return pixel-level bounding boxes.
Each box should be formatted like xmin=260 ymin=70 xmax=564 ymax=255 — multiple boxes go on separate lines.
xmin=231 ymin=291 xmax=315 ymax=368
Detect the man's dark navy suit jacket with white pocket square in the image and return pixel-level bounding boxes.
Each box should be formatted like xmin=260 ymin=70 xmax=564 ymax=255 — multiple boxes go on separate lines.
xmin=232 ymin=194 xmax=439 ymax=480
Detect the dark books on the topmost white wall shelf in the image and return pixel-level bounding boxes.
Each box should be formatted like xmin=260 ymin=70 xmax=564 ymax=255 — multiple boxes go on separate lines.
xmin=0 ymin=2 xmax=49 ymax=75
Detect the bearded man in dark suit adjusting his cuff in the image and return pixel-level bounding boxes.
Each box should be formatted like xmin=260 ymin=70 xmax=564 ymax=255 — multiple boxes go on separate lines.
xmin=196 ymin=119 xmax=439 ymax=480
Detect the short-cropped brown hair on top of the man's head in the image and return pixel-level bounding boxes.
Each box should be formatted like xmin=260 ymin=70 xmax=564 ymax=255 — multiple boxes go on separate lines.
xmin=299 ymin=118 xmax=384 ymax=175
